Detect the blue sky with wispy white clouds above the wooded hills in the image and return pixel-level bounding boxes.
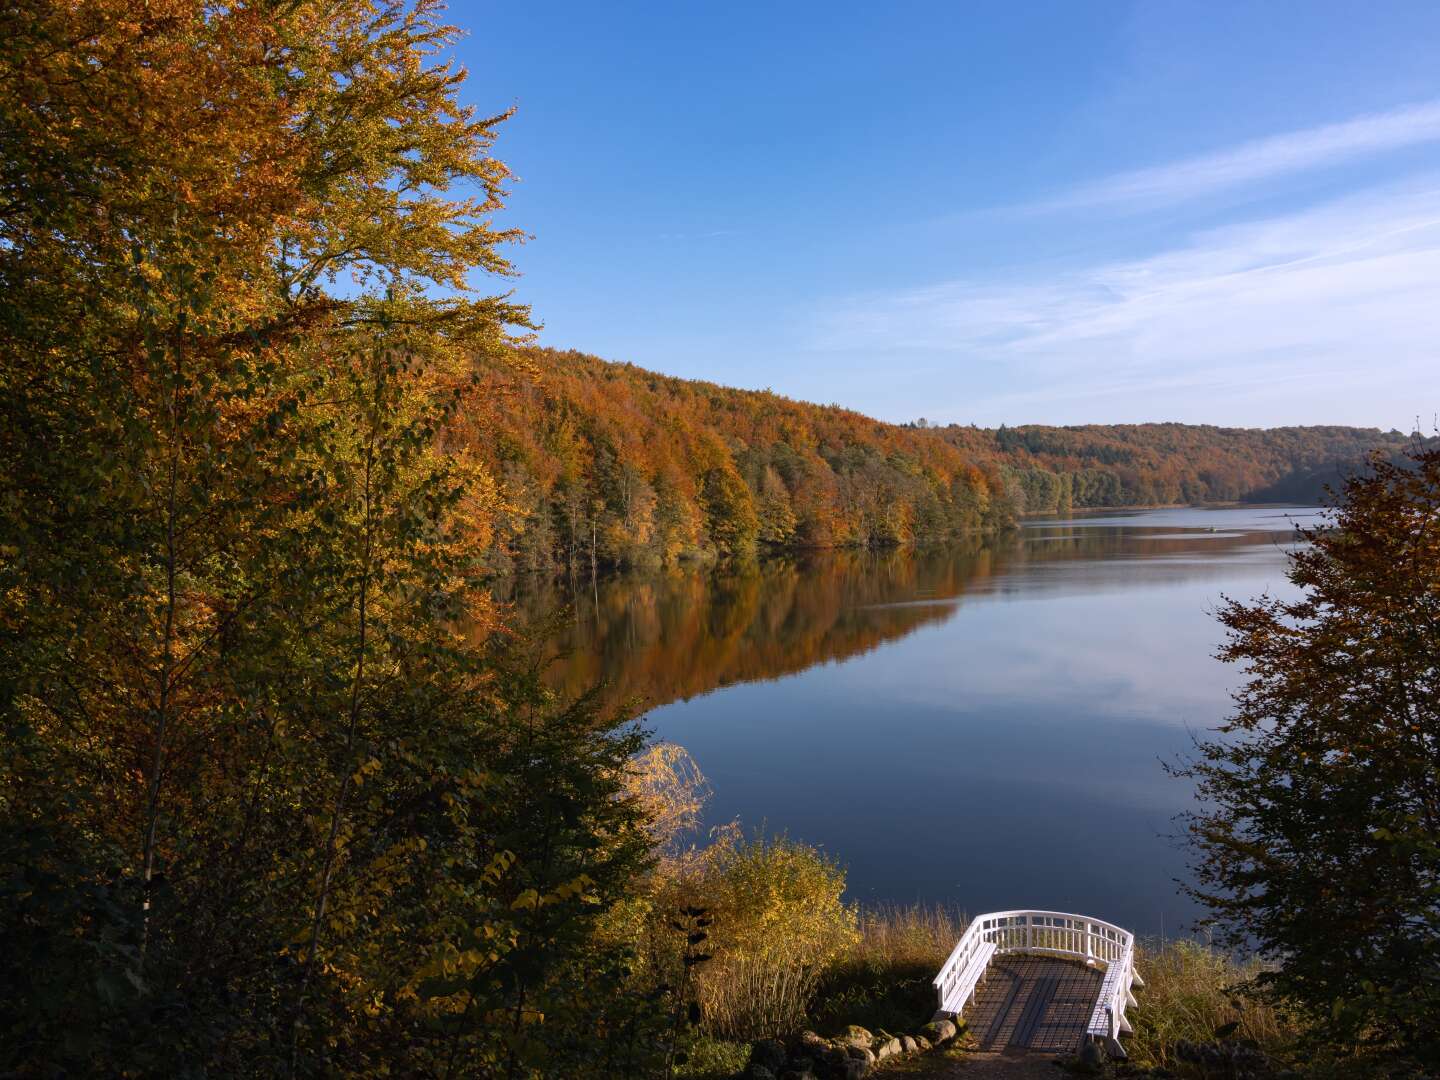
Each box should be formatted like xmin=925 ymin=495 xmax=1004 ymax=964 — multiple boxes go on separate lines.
xmin=449 ymin=0 xmax=1440 ymax=429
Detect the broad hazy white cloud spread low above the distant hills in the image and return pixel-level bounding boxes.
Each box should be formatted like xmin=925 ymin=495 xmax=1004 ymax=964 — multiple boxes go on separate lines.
xmin=809 ymin=177 xmax=1440 ymax=423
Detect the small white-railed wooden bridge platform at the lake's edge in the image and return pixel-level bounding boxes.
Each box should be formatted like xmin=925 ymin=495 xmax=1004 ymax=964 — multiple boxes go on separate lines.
xmin=935 ymin=912 xmax=1145 ymax=1057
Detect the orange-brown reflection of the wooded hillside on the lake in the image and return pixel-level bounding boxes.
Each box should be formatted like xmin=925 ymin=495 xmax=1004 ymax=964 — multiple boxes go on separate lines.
xmin=501 ymin=524 xmax=1296 ymax=707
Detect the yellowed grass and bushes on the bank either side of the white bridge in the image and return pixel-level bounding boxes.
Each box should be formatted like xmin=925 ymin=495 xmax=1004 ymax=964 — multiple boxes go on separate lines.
xmin=624 ymin=744 xmax=1296 ymax=1077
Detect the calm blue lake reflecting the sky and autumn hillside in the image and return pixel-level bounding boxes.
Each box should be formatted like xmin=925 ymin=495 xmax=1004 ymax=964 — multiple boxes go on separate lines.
xmin=506 ymin=507 xmax=1322 ymax=935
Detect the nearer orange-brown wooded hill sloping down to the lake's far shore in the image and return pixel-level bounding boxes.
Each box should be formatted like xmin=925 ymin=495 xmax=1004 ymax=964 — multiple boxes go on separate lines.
xmin=459 ymin=350 xmax=1011 ymax=569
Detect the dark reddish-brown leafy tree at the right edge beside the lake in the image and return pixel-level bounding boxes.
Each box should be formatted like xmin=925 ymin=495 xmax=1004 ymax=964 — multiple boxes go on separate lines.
xmin=1184 ymin=449 xmax=1440 ymax=1068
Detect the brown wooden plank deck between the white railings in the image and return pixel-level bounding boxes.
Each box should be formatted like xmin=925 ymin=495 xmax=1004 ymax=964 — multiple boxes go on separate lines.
xmin=965 ymin=955 xmax=1102 ymax=1054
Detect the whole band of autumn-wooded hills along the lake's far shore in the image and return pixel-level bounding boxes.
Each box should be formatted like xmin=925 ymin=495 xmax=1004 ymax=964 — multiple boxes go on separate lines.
xmin=469 ymin=348 xmax=1411 ymax=570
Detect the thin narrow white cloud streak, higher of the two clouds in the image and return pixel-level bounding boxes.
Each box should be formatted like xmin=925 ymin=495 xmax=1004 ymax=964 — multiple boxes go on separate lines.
xmin=1025 ymin=101 xmax=1440 ymax=212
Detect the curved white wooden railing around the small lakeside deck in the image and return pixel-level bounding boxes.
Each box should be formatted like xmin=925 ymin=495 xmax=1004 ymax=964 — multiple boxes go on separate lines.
xmin=935 ymin=912 xmax=1145 ymax=1057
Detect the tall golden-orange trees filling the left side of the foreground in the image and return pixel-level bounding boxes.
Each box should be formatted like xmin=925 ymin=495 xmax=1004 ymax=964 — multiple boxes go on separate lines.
xmin=0 ymin=0 xmax=662 ymax=1077
